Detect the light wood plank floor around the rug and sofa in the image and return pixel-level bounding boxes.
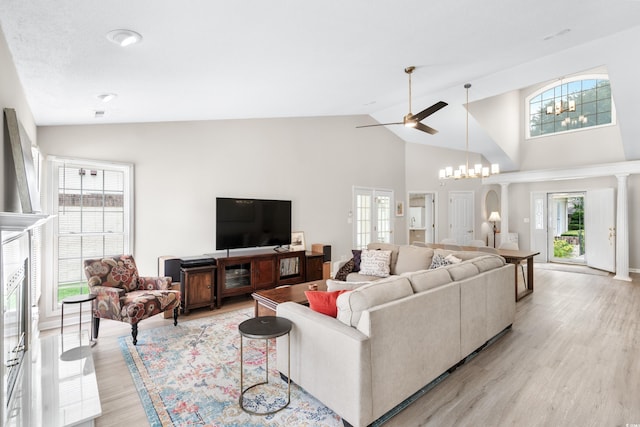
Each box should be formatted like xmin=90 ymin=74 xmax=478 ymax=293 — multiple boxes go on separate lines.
xmin=57 ymin=269 xmax=640 ymax=427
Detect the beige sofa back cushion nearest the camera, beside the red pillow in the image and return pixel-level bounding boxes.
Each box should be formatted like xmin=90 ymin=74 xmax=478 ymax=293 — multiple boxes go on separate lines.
xmin=336 ymin=276 xmax=413 ymax=327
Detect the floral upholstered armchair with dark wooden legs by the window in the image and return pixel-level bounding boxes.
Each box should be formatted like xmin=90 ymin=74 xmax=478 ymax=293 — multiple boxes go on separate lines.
xmin=84 ymin=255 xmax=180 ymax=345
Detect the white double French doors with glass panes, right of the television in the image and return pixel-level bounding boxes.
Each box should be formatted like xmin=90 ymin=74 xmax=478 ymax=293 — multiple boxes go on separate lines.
xmin=353 ymin=187 xmax=393 ymax=249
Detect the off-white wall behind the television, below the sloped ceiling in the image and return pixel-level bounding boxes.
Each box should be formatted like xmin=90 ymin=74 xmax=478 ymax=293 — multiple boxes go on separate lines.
xmin=39 ymin=117 xmax=405 ymax=274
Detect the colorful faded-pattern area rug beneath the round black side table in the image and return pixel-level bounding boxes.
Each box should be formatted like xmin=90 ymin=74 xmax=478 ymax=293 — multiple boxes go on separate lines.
xmin=118 ymin=309 xmax=342 ymax=427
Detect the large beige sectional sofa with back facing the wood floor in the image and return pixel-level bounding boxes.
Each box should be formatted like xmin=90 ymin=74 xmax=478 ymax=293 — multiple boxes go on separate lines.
xmin=277 ymin=245 xmax=515 ymax=426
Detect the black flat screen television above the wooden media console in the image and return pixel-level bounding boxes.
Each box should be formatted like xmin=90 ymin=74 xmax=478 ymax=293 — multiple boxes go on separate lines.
xmin=216 ymin=197 xmax=291 ymax=250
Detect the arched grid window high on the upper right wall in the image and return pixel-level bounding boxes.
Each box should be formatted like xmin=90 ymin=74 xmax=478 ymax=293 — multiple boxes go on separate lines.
xmin=527 ymin=75 xmax=615 ymax=138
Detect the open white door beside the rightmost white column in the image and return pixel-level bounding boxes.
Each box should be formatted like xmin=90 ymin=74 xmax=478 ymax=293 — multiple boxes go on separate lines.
xmin=584 ymin=188 xmax=616 ymax=272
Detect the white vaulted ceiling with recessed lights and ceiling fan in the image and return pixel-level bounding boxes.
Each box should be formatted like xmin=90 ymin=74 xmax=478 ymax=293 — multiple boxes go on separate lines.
xmin=0 ymin=0 xmax=640 ymax=168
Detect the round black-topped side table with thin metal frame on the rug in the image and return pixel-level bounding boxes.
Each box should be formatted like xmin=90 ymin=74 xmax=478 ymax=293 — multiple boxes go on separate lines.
xmin=238 ymin=316 xmax=292 ymax=415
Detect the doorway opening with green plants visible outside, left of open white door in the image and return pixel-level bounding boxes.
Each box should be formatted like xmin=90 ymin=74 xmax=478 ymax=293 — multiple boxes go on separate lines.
xmin=548 ymin=192 xmax=586 ymax=264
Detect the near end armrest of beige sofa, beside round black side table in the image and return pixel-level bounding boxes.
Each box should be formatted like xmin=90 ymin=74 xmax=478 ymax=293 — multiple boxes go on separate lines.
xmin=276 ymin=302 xmax=372 ymax=426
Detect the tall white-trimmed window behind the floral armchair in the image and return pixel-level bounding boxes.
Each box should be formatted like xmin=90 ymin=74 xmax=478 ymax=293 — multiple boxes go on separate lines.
xmin=49 ymin=158 xmax=133 ymax=310
